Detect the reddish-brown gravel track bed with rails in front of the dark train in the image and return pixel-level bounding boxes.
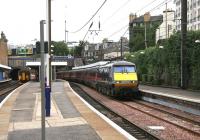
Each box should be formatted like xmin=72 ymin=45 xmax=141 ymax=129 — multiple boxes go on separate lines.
xmin=71 ymin=81 xmax=200 ymax=140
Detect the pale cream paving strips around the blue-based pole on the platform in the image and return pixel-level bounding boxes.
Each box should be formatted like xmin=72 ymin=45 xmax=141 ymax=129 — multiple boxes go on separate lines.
xmin=9 ymin=87 xmax=87 ymax=132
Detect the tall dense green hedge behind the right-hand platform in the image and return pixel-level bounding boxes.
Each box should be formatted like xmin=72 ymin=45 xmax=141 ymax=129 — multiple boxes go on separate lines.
xmin=126 ymin=31 xmax=200 ymax=89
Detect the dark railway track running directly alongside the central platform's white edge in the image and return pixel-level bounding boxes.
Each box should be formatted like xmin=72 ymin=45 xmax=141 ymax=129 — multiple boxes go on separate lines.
xmin=70 ymin=83 xmax=159 ymax=140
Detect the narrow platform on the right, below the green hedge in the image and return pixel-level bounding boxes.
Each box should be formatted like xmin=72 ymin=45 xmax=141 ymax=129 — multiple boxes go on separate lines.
xmin=139 ymin=85 xmax=200 ymax=115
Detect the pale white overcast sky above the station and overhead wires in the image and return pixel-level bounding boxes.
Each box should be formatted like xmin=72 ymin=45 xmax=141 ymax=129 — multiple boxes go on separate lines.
xmin=0 ymin=0 xmax=175 ymax=45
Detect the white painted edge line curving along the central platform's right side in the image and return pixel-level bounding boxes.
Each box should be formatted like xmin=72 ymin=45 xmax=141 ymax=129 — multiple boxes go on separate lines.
xmin=65 ymin=81 xmax=137 ymax=140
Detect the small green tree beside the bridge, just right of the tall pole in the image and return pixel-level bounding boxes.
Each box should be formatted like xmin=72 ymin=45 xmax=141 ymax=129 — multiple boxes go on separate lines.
xmin=52 ymin=41 xmax=69 ymax=56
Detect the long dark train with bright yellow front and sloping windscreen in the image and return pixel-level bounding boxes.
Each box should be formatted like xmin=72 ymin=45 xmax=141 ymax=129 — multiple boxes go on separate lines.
xmin=57 ymin=61 xmax=140 ymax=97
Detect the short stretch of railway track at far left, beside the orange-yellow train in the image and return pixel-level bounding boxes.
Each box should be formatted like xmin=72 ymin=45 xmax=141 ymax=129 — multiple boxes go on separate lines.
xmin=0 ymin=81 xmax=21 ymax=102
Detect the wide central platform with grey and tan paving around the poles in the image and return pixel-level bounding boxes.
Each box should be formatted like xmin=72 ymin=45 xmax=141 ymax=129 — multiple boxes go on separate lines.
xmin=0 ymin=81 xmax=129 ymax=140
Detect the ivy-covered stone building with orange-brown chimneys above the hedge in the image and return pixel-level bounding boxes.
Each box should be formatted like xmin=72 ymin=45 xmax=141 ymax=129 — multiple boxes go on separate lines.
xmin=129 ymin=12 xmax=163 ymax=51
